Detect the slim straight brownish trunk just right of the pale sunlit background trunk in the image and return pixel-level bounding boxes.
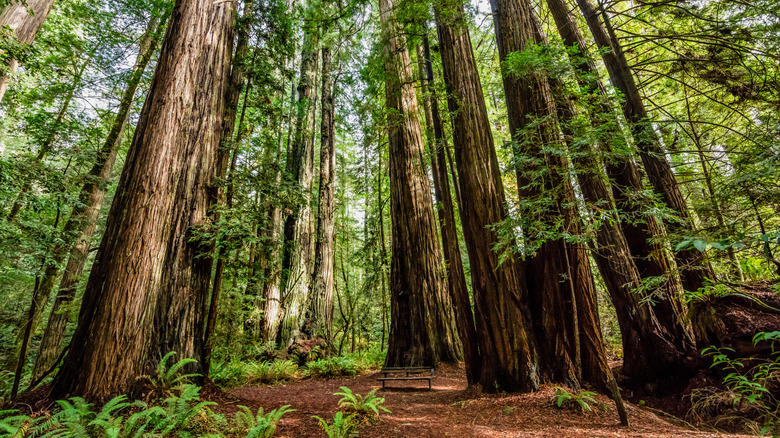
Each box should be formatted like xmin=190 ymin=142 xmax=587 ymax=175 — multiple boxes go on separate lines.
xmin=308 ymin=47 xmax=336 ymax=345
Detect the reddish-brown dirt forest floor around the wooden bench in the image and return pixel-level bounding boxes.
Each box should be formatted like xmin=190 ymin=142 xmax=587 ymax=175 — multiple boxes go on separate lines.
xmin=221 ymin=368 xmax=739 ymax=438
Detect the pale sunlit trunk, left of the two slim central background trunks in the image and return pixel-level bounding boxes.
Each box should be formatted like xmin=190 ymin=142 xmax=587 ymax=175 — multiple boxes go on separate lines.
xmin=279 ymin=27 xmax=319 ymax=347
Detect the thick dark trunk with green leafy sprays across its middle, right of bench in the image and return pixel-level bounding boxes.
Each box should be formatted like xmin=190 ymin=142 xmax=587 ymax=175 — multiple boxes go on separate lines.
xmin=491 ymin=0 xmax=592 ymax=387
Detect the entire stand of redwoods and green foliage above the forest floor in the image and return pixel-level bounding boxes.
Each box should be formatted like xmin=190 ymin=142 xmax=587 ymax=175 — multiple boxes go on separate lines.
xmin=0 ymin=0 xmax=780 ymax=436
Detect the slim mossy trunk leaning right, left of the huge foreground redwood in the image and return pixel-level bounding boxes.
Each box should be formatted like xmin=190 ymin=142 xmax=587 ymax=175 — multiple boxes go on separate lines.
xmin=33 ymin=9 xmax=170 ymax=377
